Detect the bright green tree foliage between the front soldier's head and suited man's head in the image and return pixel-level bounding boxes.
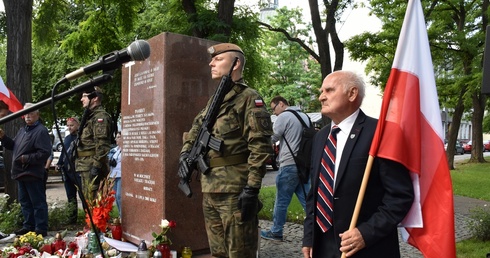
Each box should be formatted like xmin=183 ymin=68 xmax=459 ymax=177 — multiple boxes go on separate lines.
xmin=259 ymin=8 xmax=321 ymax=112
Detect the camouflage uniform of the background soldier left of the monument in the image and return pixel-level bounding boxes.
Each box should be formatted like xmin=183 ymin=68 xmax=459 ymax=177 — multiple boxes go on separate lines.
xmin=75 ymin=106 xmax=112 ymax=200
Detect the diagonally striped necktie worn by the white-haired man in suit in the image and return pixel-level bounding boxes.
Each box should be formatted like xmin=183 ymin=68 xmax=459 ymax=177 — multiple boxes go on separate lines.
xmin=316 ymin=125 xmax=340 ymax=233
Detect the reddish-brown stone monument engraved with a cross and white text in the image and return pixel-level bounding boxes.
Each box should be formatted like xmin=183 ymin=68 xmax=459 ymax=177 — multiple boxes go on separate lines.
xmin=121 ymin=32 xmax=217 ymax=253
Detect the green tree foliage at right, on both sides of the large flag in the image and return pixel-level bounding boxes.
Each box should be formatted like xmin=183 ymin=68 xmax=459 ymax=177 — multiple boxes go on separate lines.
xmin=346 ymin=0 xmax=488 ymax=168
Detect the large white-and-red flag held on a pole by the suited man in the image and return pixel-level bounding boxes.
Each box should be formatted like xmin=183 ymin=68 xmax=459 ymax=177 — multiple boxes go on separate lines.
xmin=369 ymin=0 xmax=456 ymax=258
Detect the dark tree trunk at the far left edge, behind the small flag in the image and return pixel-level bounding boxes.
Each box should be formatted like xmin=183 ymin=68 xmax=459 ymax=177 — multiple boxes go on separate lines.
xmin=3 ymin=0 xmax=32 ymax=200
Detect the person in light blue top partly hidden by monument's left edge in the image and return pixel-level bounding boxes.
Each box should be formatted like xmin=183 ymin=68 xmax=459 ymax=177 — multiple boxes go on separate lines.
xmin=107 ymin=132 xmax=122 ymax=217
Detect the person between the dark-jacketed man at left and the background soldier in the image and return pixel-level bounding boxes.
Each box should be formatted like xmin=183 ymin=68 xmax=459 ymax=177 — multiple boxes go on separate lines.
xmin=56 ymin=117 xmax=82 ymax=224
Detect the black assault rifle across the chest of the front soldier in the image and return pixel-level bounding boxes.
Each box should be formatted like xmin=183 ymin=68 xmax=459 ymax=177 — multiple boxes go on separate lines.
xmin=179 ymin=57 xmax=238 ymax=198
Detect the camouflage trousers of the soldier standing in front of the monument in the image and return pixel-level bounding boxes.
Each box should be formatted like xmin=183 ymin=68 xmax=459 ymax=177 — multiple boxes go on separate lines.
xmin=202 ymin=193 xmax=259 ymax=258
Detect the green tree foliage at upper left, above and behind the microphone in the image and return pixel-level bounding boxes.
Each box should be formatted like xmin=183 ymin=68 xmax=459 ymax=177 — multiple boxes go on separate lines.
xmin=33 ymin=0 xmax=144 ymax=133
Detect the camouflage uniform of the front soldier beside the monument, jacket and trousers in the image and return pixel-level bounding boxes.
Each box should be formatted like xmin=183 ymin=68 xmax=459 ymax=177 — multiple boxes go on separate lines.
xmin=182 ymin=81 xmax=272 ymax=257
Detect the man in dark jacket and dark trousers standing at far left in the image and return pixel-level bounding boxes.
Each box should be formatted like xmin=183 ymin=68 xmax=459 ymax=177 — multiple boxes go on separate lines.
xmin=0 ymin=103 xmax=51 ymax=236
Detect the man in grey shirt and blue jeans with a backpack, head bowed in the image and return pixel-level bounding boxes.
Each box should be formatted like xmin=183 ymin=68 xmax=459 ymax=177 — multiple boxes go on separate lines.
xmin=260 ymin=96 xmax=310 ymax=241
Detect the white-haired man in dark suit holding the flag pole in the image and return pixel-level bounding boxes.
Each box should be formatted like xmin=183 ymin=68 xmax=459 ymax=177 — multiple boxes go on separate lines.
xmin=302 ymin=71 xmax=413 ymax=258
